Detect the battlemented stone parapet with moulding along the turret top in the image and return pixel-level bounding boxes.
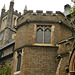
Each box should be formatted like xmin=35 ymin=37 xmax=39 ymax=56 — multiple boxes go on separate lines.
xmin=17 ymin=10 xmax=71 ymax=27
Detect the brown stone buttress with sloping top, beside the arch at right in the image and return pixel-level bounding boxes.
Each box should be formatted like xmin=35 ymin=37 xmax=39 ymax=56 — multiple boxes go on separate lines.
xmin=56 ymin=37 xmax=74 ymax=75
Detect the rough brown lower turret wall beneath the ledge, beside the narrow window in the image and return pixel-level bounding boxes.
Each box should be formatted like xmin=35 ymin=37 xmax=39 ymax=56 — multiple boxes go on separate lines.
xmin=13 ymin=46 xmax=58 ymax=75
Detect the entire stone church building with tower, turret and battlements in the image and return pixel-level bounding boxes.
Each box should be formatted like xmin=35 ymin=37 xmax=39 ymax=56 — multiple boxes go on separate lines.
xmin=0 ymin=0 xmax=75 ymax=75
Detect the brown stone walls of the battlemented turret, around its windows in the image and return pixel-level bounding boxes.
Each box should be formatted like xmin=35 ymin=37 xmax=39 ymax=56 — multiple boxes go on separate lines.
xmin=12 ymin=11 xmax=72 ymax=75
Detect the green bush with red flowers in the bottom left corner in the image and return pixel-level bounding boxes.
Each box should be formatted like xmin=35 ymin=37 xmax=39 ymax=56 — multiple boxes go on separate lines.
xmin=0 ymin=63 xmax=11 ymax=75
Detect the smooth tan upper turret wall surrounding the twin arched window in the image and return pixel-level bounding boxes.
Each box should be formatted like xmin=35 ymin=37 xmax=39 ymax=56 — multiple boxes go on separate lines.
xmin=15 ymin=23 xmax=72 ymax=49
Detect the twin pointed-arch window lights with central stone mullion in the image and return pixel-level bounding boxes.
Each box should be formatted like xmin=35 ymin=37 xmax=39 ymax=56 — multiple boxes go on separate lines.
xmin=36 ymin=25 xmax=51 ymax=44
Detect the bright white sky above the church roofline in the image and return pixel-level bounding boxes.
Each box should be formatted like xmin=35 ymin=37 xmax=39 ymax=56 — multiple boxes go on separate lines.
xmin=0 ymin=0 xmax=73 ymax=13
